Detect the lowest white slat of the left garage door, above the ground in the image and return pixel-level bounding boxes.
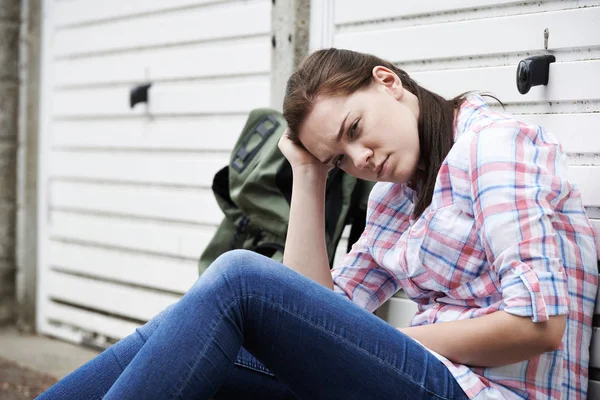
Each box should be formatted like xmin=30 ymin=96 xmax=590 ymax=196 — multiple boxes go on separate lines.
xmin=46 ymin=301 xmax=140 ymax=339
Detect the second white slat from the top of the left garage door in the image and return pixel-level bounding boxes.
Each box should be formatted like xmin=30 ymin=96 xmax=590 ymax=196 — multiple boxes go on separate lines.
xmin=54 ymin=0 xmax=271 ymax=56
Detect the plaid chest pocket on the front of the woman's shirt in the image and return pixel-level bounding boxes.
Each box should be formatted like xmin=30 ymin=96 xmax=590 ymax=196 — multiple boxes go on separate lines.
xmin=419 ymin=204 xmax=489 ymax=293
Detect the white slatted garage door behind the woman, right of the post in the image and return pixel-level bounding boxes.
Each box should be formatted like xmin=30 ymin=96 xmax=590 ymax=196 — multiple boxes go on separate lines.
xmin=311 ymin=0 xmax=600 ymax=398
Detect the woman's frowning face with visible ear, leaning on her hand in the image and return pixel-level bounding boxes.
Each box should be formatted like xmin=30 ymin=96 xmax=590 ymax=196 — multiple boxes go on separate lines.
xmin=298 ymin=67 xmax=420 ymax=184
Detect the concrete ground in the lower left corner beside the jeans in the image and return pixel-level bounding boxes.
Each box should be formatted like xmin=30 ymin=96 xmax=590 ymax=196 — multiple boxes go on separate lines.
xmin=0 ymin=327 xmax=98 ymax=400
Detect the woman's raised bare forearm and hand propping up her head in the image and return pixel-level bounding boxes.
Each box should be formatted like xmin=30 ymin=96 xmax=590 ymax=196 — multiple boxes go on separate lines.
xmin=279 ymin=130 xmax=333 ymax=289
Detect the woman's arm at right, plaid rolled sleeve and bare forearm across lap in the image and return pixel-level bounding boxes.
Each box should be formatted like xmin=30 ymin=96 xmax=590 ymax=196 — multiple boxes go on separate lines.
xmin=405 ymin=120 xmax=571 ymax=366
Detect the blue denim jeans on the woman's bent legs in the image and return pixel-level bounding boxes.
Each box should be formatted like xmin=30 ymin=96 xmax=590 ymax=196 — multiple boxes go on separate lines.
xmin=39 ymin=250 xmax=467 ymax=400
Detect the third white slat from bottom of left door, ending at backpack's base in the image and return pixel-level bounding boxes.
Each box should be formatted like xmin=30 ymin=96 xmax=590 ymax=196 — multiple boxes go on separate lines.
xmin=48 ymin=241 xmax=198 ymax=294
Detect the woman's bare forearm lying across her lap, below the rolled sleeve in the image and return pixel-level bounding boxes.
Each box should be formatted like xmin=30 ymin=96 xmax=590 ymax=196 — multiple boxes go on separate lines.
xmin=400 ymin=311 xmax=566 ymax=367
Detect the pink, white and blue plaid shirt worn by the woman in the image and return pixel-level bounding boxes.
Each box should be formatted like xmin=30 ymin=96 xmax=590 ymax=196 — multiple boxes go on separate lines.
xmin=332 ymin=96 xmax=598 ymax=399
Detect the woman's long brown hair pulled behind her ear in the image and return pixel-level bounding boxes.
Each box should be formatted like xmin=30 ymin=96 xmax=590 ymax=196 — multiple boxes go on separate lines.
xmin=283 ymin=48 xmax=465 ymax=216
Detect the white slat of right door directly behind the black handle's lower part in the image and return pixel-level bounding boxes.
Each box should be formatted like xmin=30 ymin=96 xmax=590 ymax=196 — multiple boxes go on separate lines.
xmin=412 ymin=60 xmax=600 ymax=103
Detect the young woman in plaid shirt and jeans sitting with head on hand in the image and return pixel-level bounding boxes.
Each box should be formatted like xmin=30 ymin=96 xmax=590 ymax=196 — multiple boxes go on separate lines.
xmin=41 ymin=49 xmax=598 ymax=399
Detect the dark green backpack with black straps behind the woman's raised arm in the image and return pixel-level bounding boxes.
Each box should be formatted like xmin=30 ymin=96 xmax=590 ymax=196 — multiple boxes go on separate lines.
xmin=199 ymin=109 xmax=373 ymax=274
